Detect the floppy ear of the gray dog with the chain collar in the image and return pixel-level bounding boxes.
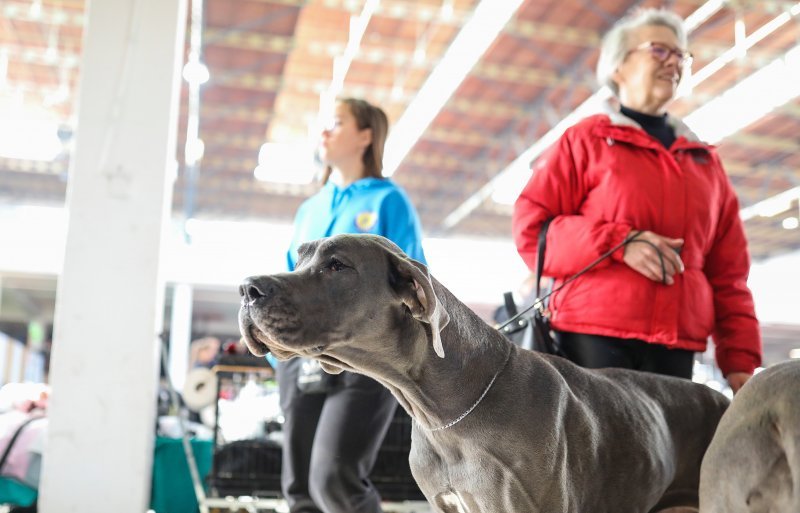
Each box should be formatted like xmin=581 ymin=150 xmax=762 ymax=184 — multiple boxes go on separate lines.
xmin=390 ymin=253 xmax=450 ymax=358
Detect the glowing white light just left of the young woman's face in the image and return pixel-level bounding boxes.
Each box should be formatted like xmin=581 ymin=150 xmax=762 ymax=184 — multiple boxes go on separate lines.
xmin=253 ymin=142 xmax=317 ymax=184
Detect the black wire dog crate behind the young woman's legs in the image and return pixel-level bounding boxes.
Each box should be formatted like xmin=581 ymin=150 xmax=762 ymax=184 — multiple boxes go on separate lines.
xmin=207 ymin=358 xmax=425 ymax=502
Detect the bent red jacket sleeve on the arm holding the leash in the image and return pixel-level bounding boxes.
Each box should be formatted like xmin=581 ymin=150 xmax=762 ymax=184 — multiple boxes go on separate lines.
xmin=512 ymin=129 xmax=632 ymax=278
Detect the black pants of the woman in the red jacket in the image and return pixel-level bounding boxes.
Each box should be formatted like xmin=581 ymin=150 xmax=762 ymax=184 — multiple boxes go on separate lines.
xmin=556 ymin=331 xmax=694 ymax=379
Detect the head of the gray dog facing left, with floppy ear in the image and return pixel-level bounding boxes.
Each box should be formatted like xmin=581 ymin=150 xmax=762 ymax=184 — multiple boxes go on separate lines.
xmin=239 ymin=234 xmax=449 ymax=372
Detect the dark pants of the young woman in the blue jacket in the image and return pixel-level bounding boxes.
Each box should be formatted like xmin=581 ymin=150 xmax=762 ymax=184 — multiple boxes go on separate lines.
xmin=278 ymin=358 xmax=397 ymax=513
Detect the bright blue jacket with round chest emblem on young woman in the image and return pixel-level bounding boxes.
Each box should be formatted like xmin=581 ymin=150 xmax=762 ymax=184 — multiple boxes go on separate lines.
xmin=287 ymin=178 xmax=427 ymax=271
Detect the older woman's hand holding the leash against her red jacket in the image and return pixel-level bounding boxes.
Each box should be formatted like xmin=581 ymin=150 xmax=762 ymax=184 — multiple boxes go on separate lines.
xmin=622 ymin=231 xmax=683 ymax=285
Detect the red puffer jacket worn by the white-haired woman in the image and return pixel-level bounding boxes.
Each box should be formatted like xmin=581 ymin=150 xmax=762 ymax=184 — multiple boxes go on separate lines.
xmin=513 ymin=107 xmax=761 ymax=375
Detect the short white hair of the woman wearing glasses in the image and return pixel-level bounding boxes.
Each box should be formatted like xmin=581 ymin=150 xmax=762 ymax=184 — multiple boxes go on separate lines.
xmin=597 ymin=9 xmax=688 ymax=96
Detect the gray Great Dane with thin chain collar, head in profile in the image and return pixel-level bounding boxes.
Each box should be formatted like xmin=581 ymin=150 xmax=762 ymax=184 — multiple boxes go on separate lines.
xmin=239 ymin=235 xmax=728 ymax=513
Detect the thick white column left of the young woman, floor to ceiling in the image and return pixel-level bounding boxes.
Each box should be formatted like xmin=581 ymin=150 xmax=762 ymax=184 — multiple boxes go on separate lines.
xmin=39 ymin=0 xmax=186 ymax=513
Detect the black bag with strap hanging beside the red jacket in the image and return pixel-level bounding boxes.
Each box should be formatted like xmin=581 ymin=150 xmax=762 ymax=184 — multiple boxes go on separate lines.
xmin=501 ymin=219 xmax=564 ymax=356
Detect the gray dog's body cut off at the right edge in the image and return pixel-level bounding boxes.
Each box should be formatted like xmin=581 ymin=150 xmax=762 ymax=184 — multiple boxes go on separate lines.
xmin=700 ymin=360 xmax=800 ymax=513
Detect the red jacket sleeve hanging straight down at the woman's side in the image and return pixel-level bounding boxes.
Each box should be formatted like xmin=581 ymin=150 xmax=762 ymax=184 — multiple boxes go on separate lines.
xmin=703 ymin=156 xmax=762 ymax=375
